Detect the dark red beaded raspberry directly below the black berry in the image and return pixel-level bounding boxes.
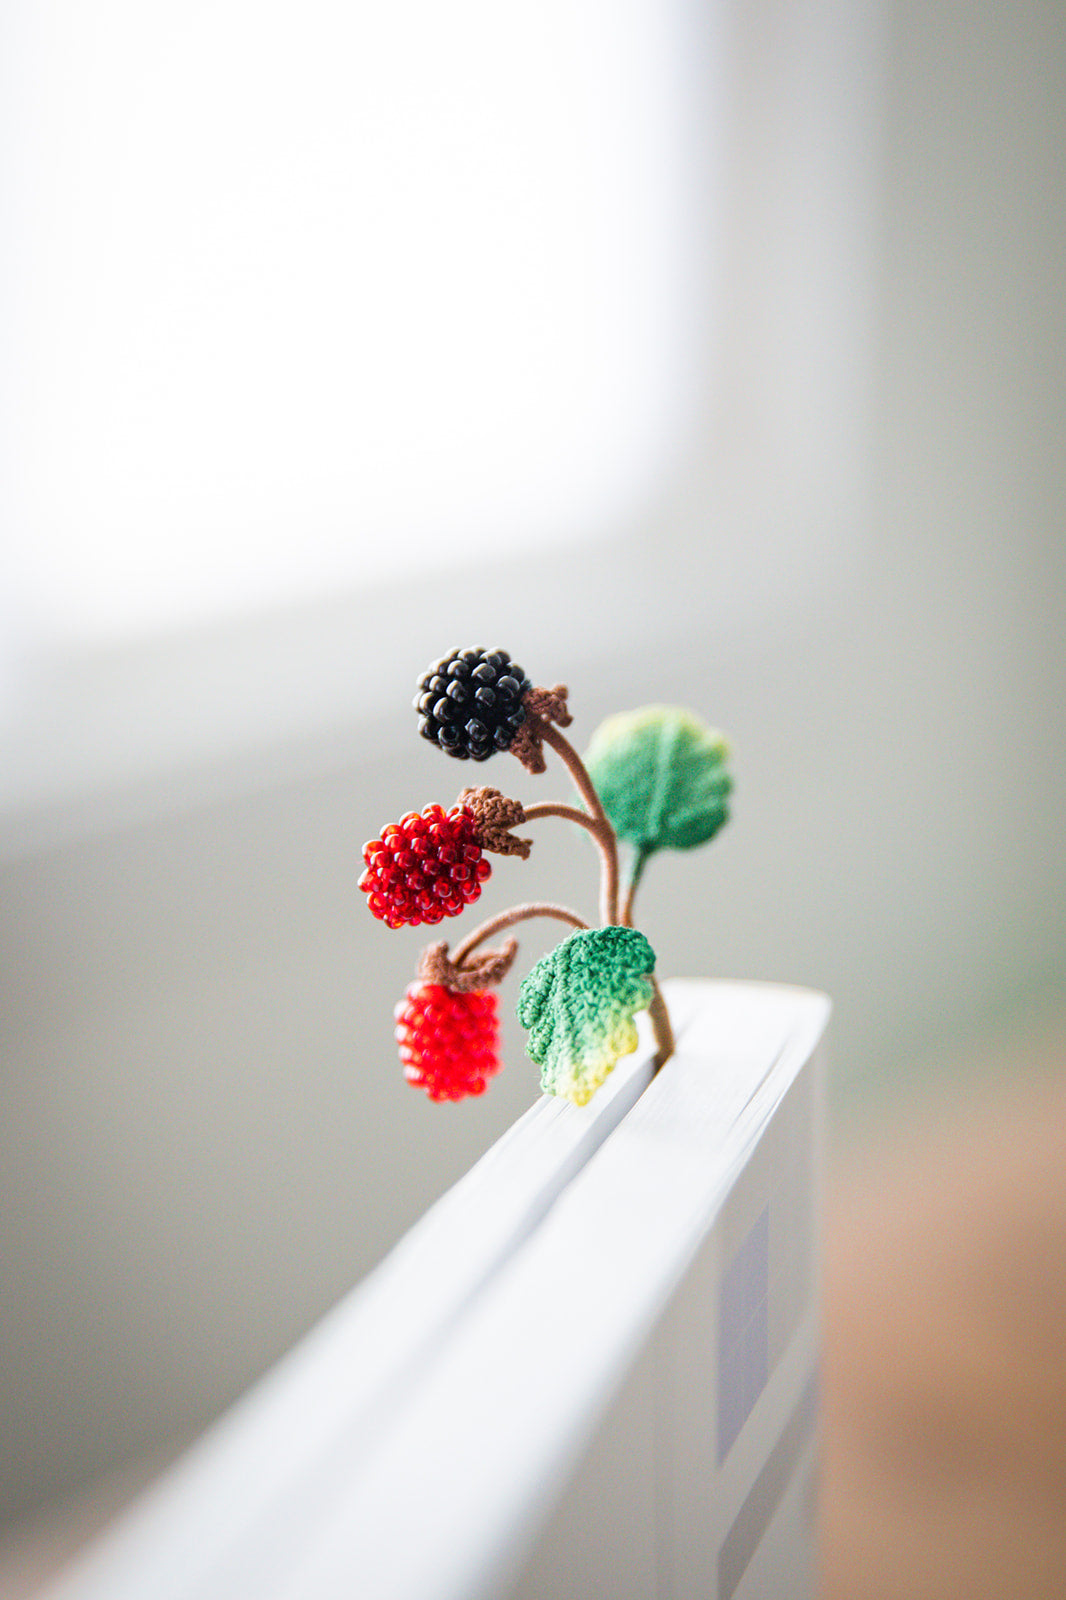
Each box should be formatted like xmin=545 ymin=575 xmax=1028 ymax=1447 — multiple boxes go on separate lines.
xmin=359 ymin=805 xmax=493 ymax=928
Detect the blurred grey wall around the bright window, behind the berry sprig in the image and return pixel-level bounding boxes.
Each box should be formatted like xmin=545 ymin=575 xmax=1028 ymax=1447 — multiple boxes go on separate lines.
xmin=0 ymin=0 xmax=1066 ymax=1515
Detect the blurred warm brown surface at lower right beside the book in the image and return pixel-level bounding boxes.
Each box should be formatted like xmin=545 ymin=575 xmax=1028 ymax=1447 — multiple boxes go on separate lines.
xmin=823 ymin=1026 xmax=1066 ymax=1600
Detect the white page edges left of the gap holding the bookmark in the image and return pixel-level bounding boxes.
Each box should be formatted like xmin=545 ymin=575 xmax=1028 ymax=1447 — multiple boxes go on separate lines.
xmin=35 ymin=990 xmax=704 ymax=1600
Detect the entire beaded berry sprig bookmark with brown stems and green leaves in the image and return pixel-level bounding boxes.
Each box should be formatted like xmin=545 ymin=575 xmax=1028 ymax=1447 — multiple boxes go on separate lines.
xmin=359 ymin=648 xmax=733 ymax=1106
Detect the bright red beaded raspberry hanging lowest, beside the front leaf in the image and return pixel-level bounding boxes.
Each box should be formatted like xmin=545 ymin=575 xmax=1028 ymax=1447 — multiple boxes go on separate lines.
xmin=395 ymin=984 xmax=499 ymax=1101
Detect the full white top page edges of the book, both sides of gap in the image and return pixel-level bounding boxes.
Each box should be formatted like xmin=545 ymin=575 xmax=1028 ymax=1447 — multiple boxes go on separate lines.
xmin=39 ymin=984 xmax=828 ymax=1600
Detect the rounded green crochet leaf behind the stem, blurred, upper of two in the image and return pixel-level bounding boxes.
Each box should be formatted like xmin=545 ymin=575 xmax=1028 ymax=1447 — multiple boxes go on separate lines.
xmin=584 ymin=706 xmax=733 ymax=856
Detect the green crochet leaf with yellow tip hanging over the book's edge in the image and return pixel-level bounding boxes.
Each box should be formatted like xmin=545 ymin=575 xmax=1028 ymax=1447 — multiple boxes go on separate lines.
xmin=519 ymin=926 xmax=655 ymax=1106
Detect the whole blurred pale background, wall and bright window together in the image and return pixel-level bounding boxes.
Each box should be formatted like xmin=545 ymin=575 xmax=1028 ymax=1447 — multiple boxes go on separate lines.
xmin=0 ymin=0 xmax=1066 ymax=1548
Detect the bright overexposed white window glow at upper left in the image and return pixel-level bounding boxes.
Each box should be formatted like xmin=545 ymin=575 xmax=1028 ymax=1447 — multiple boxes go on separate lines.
xmin=0 ymin=0 xmax=710 ymax=638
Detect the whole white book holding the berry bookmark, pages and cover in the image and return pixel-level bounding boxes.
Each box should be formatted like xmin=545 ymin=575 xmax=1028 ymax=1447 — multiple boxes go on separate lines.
xmin=39 ymin=982 xmax=829 ymax=1600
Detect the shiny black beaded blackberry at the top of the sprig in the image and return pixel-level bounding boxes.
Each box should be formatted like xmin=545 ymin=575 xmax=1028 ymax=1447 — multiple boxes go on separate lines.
xmin=415 ymin=650 xmax=533 ymax=762
